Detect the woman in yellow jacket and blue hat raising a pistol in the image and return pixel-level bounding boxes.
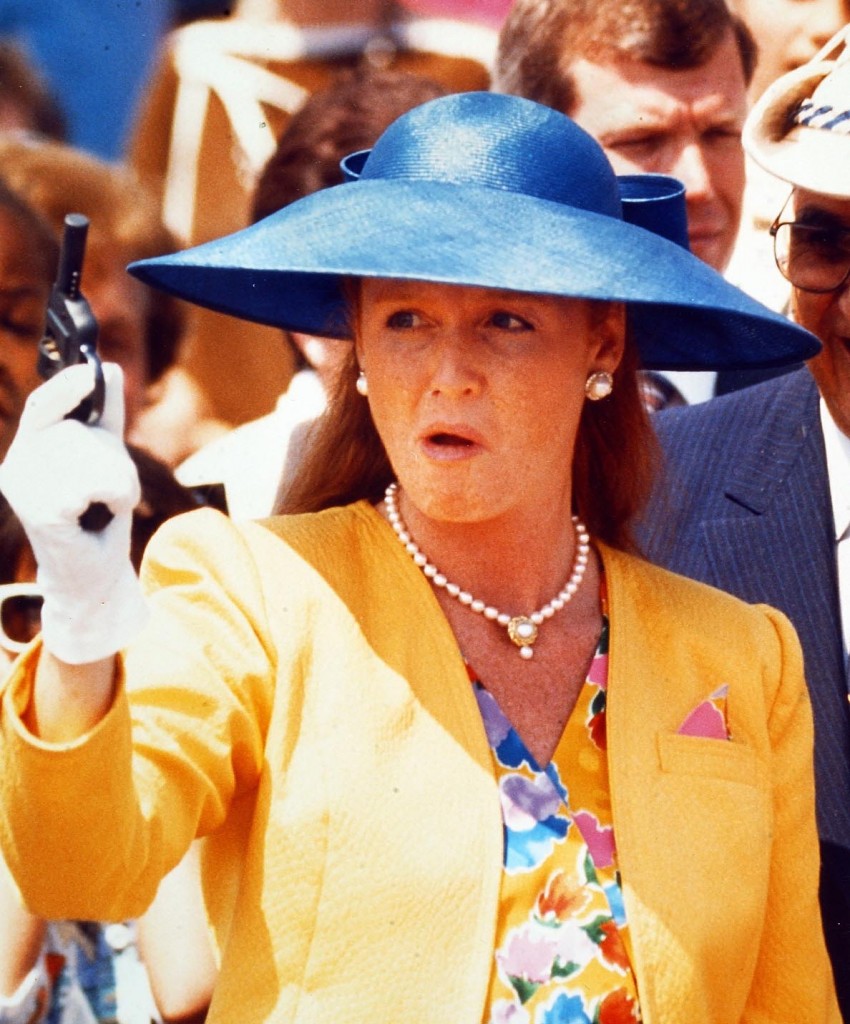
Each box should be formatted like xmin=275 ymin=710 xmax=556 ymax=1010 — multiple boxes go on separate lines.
xmin=0 ymin=93 xmax=838 ymax=1024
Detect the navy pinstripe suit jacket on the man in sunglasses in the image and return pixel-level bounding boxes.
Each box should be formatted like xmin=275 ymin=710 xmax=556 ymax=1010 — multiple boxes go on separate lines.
xmin=638 ymin=370 xmax=850 ymax=1007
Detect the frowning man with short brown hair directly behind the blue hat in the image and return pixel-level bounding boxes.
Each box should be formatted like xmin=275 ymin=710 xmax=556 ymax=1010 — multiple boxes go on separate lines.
xmin=493 ymin=0 xmax=755 ymax=271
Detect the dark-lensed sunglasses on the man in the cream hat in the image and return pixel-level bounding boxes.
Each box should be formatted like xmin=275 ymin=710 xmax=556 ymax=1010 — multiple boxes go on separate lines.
xmin=770 ymin=196 xmax=850 ymax=294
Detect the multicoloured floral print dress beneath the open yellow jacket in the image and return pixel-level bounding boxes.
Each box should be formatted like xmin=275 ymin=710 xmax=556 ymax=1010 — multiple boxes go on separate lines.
xmin=470 ymin=604 xmax=640 ymax=1024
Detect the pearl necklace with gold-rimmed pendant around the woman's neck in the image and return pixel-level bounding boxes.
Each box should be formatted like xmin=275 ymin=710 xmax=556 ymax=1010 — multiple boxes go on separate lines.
xmin=384 ymin=482 xmax=590 ymax=660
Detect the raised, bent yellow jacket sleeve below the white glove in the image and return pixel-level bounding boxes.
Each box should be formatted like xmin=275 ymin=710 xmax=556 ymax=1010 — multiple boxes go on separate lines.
xmin=0 ymin=510 xmax=275 ymax=921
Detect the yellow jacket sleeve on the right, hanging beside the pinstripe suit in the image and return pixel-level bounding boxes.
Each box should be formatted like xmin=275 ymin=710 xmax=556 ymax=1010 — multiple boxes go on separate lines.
xmin=743 ymin=607 xmax=841 ymax=1024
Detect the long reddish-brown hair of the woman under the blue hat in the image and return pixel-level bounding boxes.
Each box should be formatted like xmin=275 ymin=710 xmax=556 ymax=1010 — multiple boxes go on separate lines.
xmin=274 ymin=286 xmax=658 ymax=551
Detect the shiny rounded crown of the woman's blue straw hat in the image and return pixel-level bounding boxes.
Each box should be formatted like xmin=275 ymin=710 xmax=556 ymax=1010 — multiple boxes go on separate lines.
xmin=359 ymin=92 xmax=623 ymax=218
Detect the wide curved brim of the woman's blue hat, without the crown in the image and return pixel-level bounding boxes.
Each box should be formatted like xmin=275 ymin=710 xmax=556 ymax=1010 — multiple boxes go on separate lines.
xmin=129 ymin=179 xmax=819 ymax=370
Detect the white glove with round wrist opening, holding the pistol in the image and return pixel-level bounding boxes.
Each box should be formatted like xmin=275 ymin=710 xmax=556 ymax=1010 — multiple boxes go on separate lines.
xmin=0 ymin=364 xmax=147 ymax=665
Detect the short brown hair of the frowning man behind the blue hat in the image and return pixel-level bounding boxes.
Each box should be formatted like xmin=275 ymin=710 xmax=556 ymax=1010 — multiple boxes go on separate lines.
xmin=493 ymin=0 xmax=757 ymax=114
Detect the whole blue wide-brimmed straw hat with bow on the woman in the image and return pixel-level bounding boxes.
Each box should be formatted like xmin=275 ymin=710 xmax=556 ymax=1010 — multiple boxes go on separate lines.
xmin=129 ymin=92 xmax=819 ymax=370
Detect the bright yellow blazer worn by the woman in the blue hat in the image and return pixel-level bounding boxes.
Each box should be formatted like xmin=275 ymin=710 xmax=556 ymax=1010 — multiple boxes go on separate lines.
xmin=0 ymin=503 xmax=839 ymax=1024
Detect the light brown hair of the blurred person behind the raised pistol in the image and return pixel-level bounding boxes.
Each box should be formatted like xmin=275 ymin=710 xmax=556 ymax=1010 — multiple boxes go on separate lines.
xmin=0 ymin=137 xmax=184 ymax=383
